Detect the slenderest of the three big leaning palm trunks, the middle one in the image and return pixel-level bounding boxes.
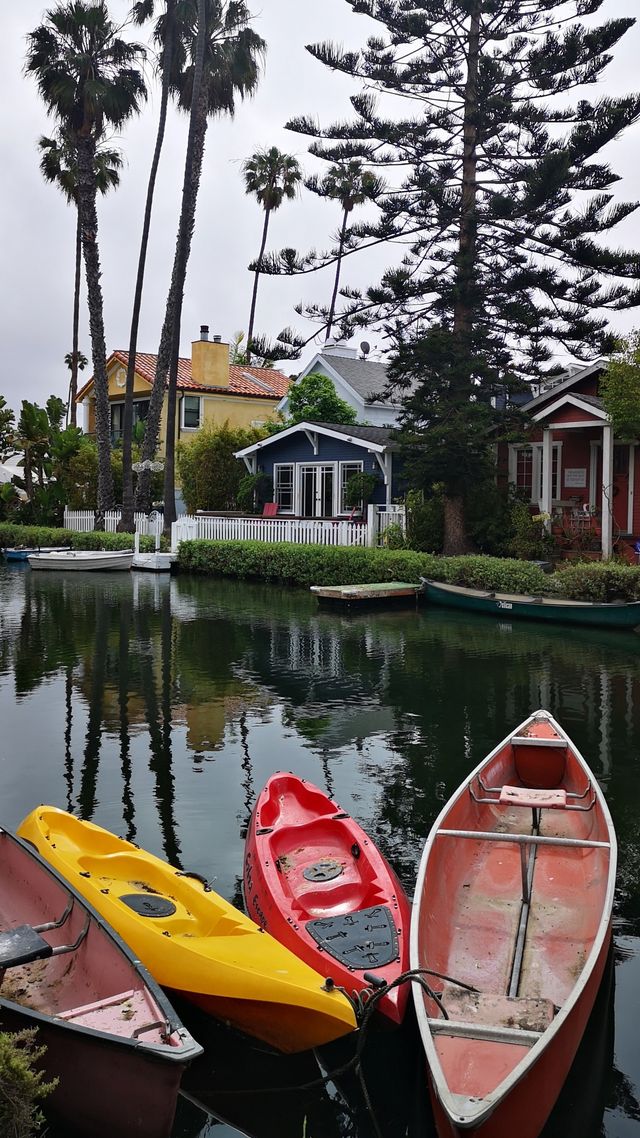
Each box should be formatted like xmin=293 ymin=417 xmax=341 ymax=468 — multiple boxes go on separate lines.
xmin=118 ymin=0 xmax=175 ymax=533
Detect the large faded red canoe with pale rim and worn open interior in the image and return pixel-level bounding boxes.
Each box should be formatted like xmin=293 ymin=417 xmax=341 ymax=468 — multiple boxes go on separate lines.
xmin=411 ymin=711 xmax=616 ymax=1138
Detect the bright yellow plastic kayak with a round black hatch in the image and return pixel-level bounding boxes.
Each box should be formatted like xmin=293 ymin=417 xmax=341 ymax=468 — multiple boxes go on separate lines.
xmin=18 ymin=806 xmax=356 ymax=1052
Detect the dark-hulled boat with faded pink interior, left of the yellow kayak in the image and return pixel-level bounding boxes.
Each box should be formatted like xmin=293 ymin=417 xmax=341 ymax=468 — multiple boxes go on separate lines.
xmin=0 ymin=830 xmax=202 ymax=1138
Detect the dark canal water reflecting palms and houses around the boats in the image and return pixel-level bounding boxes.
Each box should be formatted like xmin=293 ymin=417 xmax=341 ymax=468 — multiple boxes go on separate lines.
xmin=0 ymin=562 xmax=640 ymax=1138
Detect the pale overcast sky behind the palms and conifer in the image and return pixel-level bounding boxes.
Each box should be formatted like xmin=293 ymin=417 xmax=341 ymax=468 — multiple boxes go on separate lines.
xmin=0 ymin=0 xmax=640 ymax=410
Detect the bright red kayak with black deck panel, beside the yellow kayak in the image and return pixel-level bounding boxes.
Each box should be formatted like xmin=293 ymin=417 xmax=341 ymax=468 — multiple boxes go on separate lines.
xmin=244 ymin=773 xmax=410 ymax=1023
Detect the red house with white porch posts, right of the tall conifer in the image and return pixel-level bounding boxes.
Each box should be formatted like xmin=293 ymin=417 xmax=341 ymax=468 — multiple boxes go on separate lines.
xmin=507 ymin=360 xmax=640 ymax=560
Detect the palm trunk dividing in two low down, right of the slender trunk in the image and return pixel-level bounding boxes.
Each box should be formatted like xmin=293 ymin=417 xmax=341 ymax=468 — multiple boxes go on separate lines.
xmin=137 ymin=0 xmax=207 ymax=531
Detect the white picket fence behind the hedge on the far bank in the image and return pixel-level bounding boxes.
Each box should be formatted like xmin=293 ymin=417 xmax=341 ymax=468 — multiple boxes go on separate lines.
xmin=64 ymin=505 xmax=404 ymax=550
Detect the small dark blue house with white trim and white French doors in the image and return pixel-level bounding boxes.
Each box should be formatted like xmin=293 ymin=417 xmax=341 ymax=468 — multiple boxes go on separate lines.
xmin=236 ymin=421 xmax=403 ymax=518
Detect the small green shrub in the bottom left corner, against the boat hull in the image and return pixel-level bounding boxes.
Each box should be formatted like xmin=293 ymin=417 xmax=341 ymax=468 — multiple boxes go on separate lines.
xmin=0 ymin=1030 xmax=57 ymax=1138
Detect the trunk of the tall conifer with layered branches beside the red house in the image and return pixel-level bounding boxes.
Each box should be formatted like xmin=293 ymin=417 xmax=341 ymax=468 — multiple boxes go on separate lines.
xmin=443 ymin=0 xmax=482 ymax=555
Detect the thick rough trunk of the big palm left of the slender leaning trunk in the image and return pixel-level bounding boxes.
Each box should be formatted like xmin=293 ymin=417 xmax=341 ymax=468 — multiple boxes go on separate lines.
xmin=77 ymin=135 xmax=114 ymax=529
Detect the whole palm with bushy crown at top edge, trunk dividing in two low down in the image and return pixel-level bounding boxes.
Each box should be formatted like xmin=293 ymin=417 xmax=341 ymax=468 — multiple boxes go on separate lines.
xmin=137 ymin=0 xmax=265 ymax=528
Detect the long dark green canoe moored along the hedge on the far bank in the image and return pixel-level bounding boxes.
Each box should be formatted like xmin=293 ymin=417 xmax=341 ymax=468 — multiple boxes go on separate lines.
xmin=425 ymin=582 xmax=640 ymax=628
